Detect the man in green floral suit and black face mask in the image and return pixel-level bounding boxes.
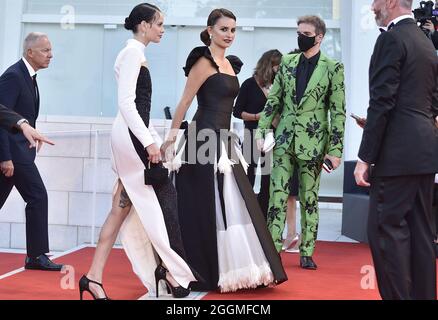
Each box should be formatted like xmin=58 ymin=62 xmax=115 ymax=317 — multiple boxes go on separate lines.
xmin=256 ymin=16 xmax=345 ymax=270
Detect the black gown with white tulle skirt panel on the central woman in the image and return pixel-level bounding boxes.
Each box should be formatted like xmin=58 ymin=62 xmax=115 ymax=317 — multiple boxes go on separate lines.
xmin=176 ymin=47 xmax=287 ymax=292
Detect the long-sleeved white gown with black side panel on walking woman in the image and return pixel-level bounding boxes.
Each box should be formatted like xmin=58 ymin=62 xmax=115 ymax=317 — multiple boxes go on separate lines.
xmin=111 ymin=39 xmax=196 ymax=295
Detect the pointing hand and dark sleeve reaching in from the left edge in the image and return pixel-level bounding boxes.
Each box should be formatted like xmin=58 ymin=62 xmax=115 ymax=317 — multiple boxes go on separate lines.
xmin=0 ymin=104 xmax=54 ymax=148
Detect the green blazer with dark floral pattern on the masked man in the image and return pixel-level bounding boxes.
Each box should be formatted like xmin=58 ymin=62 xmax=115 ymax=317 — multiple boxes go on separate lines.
xmin=256 ymin=53 xmax=345 ymax=161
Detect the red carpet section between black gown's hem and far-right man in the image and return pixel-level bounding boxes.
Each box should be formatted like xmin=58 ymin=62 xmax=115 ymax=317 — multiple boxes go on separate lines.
xmin=204 ymin=242 xmax=380 ymax=300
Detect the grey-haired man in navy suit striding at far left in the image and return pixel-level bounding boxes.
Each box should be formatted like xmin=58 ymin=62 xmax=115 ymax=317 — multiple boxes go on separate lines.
xmin=0 ymin=33 xmax=62 ymax=271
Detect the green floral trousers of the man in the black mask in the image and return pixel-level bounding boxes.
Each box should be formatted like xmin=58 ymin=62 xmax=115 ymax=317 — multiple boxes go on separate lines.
xmin=268 ymin=148 xmax=323 ymax=257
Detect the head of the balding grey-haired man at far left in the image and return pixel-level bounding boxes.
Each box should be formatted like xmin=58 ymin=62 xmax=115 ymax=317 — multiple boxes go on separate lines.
xmin=23 ymin=32 xmax=53 ymax=71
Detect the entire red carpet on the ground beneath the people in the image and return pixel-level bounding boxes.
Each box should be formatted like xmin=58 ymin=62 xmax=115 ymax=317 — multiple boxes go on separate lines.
xmin=0 ymin=242 xmax=414 ymax=300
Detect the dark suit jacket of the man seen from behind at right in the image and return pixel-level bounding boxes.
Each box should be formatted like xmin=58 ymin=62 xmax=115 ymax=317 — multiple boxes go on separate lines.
xmin=359 ymin=19 xmax=438 ymax=176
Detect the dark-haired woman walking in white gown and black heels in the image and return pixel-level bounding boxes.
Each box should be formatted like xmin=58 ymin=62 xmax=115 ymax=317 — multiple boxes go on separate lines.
xmin=79 ymin=3 xmax=195 ymax=299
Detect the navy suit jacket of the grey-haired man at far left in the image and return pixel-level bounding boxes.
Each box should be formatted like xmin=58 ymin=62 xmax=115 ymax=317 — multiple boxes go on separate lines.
xmin=0 ymin=60 xmax=39 ymax=164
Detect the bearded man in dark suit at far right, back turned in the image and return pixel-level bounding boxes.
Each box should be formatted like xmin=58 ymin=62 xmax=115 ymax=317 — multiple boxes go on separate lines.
xmin=355 ymin=0 xmax=438 ymax=300
